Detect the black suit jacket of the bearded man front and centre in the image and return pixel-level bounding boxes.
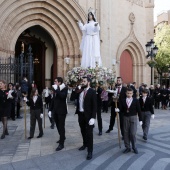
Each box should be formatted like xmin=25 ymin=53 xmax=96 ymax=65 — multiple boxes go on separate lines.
xmin=75 ymin=88 xmax=97 ymax=120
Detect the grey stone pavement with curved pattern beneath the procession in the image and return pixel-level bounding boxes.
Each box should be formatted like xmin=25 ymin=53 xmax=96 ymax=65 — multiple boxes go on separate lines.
xmin=0 ymin=104 xmax=170 ymax=170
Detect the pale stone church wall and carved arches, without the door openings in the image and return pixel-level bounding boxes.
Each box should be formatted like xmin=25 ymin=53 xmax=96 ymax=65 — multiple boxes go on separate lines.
xmin=0 ymin=0 xmax=154 ymax=84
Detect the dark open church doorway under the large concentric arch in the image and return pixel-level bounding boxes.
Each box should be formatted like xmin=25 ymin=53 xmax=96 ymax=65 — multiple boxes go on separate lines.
xmin=15 ymin=26 xmax=57 ymax=93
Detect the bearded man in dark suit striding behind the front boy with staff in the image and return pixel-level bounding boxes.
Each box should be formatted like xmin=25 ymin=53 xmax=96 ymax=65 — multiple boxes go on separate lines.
xmin=106 ymin=77 xmax=126 ymax=139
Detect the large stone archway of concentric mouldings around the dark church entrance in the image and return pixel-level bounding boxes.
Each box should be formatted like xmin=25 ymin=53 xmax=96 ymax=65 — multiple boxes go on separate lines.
xmin=0 ymin=0 xmax=86 ymax=76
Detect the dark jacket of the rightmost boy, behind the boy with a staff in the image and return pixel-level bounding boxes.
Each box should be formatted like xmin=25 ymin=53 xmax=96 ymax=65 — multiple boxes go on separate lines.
xmin=139 ymin=97 xmax=154 ymax=114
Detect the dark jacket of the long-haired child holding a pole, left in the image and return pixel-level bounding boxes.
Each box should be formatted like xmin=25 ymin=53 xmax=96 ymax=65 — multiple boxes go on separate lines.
xmin=27 ymin=96 xmax=43 ymax=113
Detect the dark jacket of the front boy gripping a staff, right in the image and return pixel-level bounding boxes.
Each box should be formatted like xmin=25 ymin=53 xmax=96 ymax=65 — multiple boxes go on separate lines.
xmin=120 ymin=98 xmax=142 ymax=121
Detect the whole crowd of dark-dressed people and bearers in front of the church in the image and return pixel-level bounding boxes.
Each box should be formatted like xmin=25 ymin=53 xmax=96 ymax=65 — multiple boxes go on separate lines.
xmin=0 ymin=77 xmax=170 ymax=160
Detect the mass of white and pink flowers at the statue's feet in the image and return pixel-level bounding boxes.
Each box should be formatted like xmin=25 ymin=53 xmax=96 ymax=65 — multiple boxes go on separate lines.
xmin=66 ymin=66 xmax=115 ymax=87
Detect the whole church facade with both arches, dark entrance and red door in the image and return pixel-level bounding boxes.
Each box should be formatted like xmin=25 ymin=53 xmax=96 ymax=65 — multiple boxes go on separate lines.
xmin=0 ymin=0 xmax=154 ymax=88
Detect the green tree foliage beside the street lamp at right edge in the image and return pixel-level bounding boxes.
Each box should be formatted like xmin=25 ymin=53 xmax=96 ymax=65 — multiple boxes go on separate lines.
xmin=154 ymin=25 xmax=170 ymax=75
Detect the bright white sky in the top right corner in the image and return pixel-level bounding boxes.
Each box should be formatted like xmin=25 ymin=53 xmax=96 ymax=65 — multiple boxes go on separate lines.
xmin=154 ymin=0 xmax=170 ymax=21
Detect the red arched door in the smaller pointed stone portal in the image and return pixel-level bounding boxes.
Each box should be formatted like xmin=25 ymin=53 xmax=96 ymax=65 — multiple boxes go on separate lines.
xmin=120 ymin=50 xmax=133 ymax=84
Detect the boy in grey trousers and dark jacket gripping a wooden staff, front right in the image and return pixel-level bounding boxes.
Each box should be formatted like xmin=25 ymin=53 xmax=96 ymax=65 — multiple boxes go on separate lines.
xmin=115 ymin=88 xmax=142 ymax=154
